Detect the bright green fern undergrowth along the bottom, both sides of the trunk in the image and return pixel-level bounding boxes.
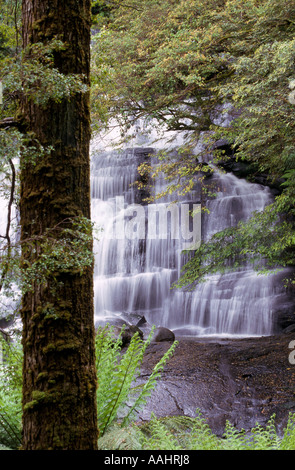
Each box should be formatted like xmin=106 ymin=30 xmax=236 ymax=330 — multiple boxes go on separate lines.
xmin=0 ymin=326 xmax=295 ymax=450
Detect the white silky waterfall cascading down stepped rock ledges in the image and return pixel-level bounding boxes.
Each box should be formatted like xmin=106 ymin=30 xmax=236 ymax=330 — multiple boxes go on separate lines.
xmin=92 ymin=124 xmax=292 ymax=336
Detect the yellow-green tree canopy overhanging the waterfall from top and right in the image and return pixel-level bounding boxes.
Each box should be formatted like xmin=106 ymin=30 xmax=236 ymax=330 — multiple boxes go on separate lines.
xmin=93 ymin=0 xmax=295 ymax=285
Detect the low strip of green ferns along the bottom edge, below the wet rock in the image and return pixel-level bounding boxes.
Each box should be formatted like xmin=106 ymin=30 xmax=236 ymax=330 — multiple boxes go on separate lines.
xmin=99 ymin=410 xmax=295 ymax=451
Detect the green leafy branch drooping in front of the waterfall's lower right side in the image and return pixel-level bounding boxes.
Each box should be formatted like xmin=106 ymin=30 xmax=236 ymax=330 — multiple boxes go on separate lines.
xmin=175 ymin=199 xmax=295 ymax=288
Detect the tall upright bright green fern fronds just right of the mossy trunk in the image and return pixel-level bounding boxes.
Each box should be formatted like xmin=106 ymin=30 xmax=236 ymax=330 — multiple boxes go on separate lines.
xmin=95 ymin=325 xmax=178 ymax=436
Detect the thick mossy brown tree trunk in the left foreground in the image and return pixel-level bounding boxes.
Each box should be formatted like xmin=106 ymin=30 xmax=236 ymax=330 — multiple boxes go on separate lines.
xmin=20 ymin=0 xmax=98 ymax=450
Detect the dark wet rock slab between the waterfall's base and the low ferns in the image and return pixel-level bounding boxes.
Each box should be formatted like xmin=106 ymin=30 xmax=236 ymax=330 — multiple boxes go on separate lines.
xmin=140 ymin=333 xmax=295 ymax=436
